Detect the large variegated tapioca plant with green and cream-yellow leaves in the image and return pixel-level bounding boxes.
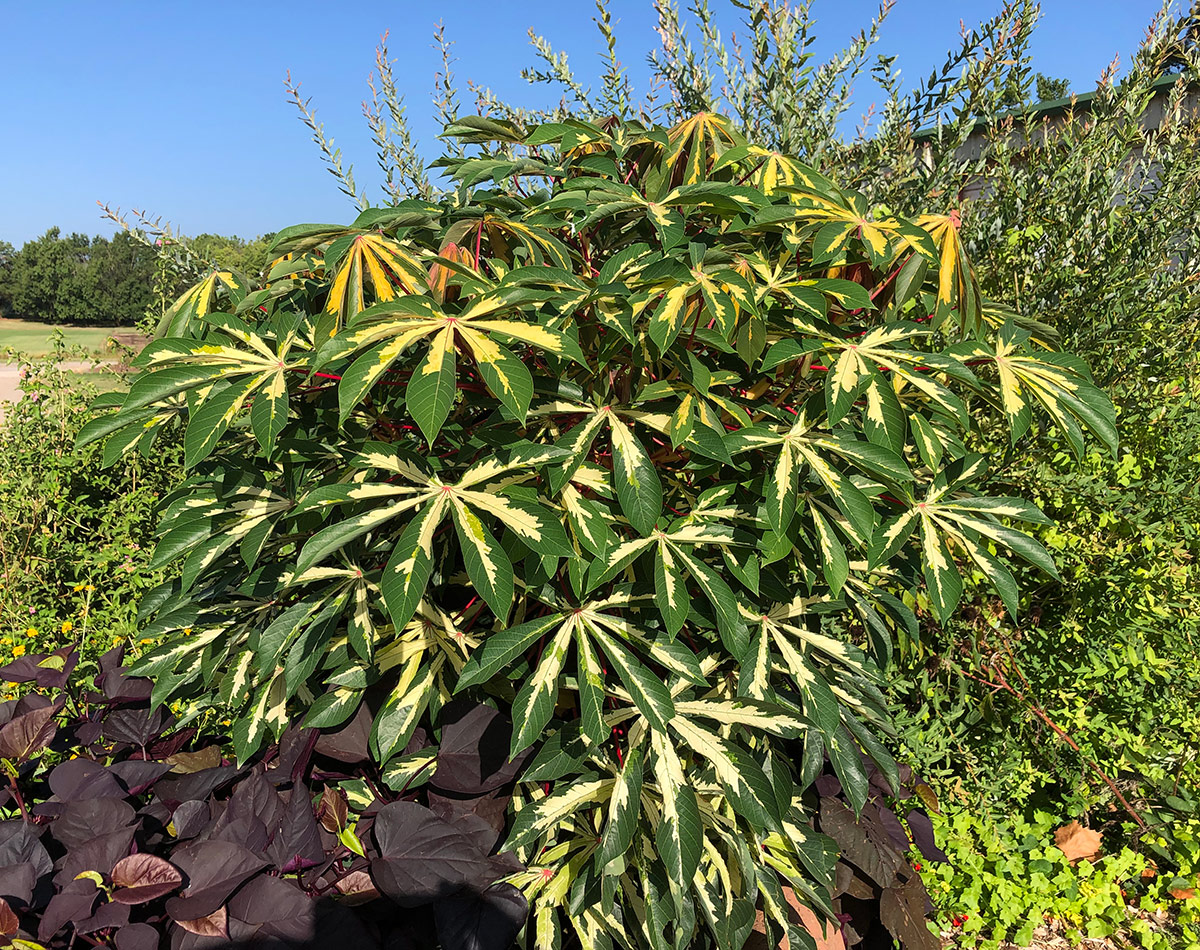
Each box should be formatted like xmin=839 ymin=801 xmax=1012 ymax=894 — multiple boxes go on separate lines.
xmin=83 ymin=114 xmax=1116 ymax=950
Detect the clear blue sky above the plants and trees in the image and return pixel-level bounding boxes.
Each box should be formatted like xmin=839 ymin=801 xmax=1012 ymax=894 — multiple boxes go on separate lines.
xmin=0 ymin=0 xmax=1176 ymax=246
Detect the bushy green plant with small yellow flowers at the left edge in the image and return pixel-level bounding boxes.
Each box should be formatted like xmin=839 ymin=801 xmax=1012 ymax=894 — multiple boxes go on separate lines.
xmin=0 ymin=333 xmax=181 ymax=667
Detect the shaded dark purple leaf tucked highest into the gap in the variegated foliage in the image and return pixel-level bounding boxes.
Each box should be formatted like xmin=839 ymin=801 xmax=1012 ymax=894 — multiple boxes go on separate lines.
xmin=430 ymin=699 xmax=526 ymax=795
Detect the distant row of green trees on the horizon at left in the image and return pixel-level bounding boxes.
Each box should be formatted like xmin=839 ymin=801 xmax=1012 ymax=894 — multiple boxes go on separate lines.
xmin=0 ymin=228 xmax=270 ymax=326
